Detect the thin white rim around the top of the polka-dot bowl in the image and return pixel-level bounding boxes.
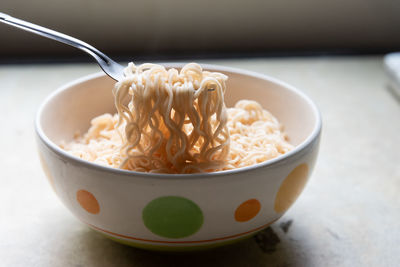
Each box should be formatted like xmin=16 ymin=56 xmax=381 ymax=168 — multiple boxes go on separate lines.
xmin=35 ymin=62 xmax=322 ymax=180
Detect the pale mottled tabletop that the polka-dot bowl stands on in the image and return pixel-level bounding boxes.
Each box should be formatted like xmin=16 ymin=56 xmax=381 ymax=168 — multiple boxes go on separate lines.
xmin=0 ymin=56 xmax=400 ymax=267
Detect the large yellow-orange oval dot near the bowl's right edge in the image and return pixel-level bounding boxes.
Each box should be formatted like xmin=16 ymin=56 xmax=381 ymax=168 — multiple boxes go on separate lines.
xmin=274 ymin=163 xmax=308 ymax=213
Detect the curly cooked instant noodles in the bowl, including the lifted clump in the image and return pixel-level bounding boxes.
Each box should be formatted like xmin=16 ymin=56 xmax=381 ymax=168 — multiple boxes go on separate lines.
xmin=62 ymin=63 xmax=292 ymax=173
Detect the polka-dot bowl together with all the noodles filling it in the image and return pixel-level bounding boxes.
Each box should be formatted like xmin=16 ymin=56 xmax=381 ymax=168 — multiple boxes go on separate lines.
xmin=35 ymin=63 xmax=321 ymax=251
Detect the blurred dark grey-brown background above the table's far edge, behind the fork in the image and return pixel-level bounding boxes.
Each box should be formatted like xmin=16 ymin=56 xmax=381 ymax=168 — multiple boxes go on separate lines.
xmin=0 ymin=0 xmax=400 ymax=63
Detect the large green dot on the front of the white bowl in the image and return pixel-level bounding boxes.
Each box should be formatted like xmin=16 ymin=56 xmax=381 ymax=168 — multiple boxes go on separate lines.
xmin=142 ymin=196 xmax=203 ymax=238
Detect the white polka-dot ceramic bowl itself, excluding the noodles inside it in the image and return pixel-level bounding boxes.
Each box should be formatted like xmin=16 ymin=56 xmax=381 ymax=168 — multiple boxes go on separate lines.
xmin=35 ymin=64 xmax=321 ymax=251
